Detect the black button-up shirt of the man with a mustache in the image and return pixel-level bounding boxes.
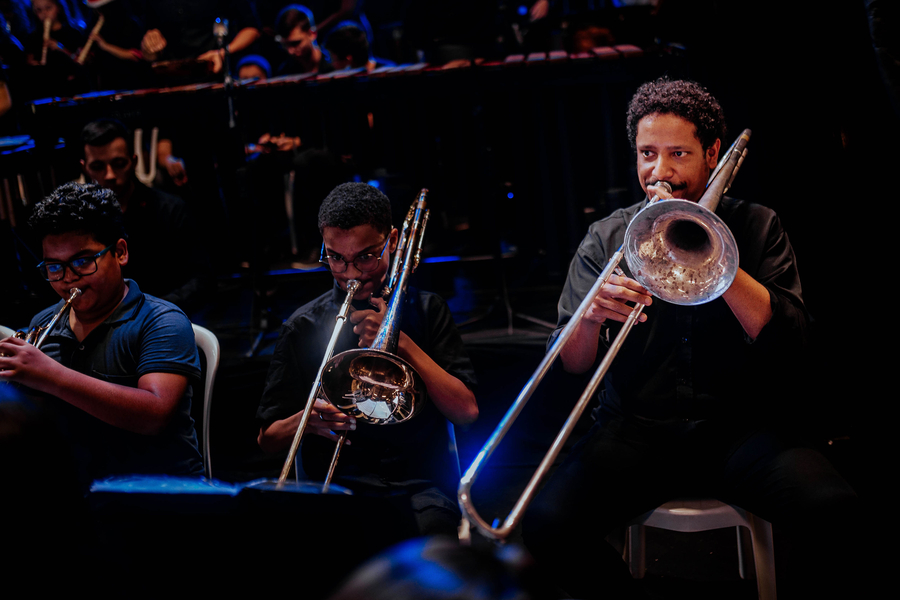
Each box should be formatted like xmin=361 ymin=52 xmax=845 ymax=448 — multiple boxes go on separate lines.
xmin=551 ymin=198 xmax=809 ymax=420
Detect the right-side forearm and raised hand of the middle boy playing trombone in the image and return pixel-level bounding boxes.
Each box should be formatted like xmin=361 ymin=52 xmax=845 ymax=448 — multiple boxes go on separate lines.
xmin=350 ymin=298 xmax=478 ymax=425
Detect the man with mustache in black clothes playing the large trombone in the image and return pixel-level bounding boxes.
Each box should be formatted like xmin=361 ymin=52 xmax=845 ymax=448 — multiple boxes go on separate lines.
xmin=523 ymin=78 xmax=857 ymax=598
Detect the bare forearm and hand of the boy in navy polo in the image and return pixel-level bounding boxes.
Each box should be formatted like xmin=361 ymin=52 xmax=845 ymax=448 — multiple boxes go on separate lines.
xmin=0 ymin=338 xmax=188 ymax=435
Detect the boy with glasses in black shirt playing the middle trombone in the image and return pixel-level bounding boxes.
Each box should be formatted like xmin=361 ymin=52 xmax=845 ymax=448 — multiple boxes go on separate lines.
xmin=257 ymin=183 xmax=478 ymax=537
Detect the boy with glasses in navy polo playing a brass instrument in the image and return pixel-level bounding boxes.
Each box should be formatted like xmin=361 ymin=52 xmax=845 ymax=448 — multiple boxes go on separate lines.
xmin=0 ymin=183 xmax=203 ymax=484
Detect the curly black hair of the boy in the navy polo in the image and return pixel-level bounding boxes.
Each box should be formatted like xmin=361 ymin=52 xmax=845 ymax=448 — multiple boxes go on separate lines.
xmin=28 ymin=182 xmax=128 ymax=246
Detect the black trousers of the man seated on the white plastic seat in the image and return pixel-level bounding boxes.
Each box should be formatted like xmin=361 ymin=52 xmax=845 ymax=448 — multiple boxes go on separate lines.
xmin=523 ymin=417 xmax=859 ymax=598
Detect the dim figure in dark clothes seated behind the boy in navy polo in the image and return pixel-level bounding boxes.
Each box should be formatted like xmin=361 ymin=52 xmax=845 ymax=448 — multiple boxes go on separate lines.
xmin=81 ymin=119 xmax=213 ymax=311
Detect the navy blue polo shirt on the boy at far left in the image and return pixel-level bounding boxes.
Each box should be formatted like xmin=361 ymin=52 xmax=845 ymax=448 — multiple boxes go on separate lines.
xmin=31 ymin=279 xmax=203 ymax=479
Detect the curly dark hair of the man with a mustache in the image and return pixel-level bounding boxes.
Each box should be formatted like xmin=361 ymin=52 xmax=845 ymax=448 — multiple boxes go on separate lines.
xmin=626 ymin=77 xmax=725 ymax=150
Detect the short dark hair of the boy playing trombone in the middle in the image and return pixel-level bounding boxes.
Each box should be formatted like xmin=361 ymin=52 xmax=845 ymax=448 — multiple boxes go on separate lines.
xmin=319 ymin=182 xmax=391 ymax=235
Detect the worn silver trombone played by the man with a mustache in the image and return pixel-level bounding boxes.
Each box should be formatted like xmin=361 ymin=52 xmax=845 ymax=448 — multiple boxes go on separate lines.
xmin=457 ymin=129 xmax=750 ymax=540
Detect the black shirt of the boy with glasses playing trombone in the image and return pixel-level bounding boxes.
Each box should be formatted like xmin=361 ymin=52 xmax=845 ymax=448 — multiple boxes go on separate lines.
xmin=257 ymin=285 xmax=475 ymax=497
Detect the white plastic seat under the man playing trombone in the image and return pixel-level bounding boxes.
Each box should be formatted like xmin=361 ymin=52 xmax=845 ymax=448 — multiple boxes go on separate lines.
xmin=625 ymin=499 xmax=776 ymax=600
